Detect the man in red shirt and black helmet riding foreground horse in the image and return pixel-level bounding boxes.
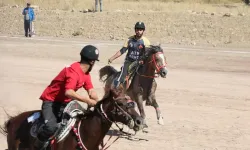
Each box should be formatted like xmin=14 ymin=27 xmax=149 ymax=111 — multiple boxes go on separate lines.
xmin=35 ymin=45 xmax=99 ymax=150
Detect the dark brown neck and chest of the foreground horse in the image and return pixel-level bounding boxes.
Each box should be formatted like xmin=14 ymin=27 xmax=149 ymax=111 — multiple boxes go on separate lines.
xmin=81 ymin=99 xmax=112 ymax=149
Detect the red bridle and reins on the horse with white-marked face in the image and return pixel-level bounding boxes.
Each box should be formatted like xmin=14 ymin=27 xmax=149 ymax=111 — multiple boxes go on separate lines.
xmin=136 ymin=52 xmax=167 ymax=78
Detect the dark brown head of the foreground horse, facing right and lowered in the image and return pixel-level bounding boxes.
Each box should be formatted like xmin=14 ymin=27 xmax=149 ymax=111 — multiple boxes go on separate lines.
xmin=96 ymin=86 xmax=143 ymax=131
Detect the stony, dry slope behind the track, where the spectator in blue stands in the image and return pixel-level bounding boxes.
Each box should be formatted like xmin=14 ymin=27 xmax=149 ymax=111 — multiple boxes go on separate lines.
xmin=0 ymin=0 xmax=250 ymax=47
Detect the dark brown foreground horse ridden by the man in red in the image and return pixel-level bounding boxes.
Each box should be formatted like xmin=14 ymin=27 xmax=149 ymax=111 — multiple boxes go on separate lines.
xmin=2 ymin=85 xmax=143 ymax=150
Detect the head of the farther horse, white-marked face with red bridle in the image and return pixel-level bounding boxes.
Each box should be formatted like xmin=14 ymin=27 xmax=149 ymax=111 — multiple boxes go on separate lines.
xmin=144 ymin=45 xmax=168 ymax=78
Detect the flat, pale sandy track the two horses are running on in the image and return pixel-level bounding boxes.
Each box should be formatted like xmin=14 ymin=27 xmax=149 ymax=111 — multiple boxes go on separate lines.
xmin=0 ymin=34 xmax=250 ymax=150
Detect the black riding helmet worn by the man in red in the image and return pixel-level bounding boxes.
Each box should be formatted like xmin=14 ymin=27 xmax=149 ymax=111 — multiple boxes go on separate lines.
xmin=80 ymin=45 xmax=99 ymax=61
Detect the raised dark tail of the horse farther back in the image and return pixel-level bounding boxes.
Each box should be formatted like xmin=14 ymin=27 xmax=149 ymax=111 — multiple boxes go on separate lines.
xmin=99 ymin=66 xmax=118 ymax=82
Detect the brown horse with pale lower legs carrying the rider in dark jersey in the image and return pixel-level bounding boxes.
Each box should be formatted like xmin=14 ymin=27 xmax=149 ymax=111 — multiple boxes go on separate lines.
xmin=99 ymin=45 xmax=167 ymax=127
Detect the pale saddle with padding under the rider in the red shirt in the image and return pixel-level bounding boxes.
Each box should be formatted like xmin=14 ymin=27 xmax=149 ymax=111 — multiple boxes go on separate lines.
xmin=27 ymin=100 xmax=86 ymax=143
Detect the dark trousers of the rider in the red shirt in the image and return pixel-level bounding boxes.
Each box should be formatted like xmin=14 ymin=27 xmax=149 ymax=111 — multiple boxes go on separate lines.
xmin=37 ymin=101 xmax=66 ymax=142
